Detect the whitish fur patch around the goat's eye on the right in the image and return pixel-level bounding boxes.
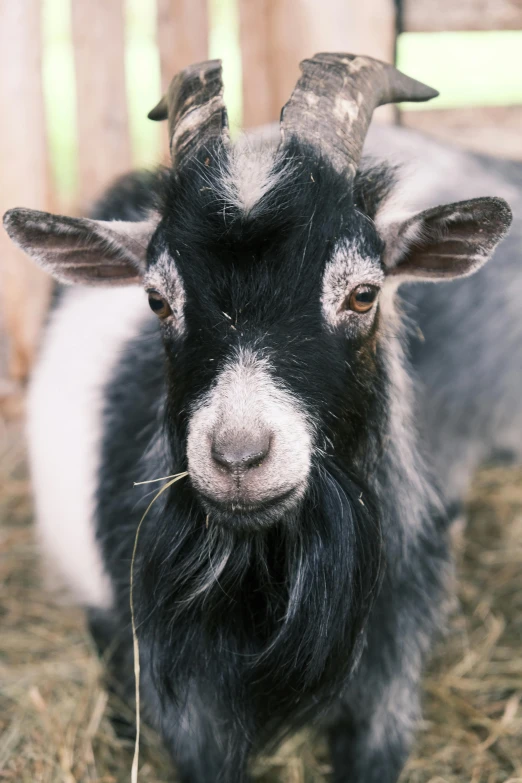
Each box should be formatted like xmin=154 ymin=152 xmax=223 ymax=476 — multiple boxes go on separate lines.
xmin=321 ymin=240 xmax=384 ymax=332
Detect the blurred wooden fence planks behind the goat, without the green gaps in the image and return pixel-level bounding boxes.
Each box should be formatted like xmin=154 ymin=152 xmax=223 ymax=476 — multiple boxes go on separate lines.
xmin=0 ymin=0 xmax=522 ymax=397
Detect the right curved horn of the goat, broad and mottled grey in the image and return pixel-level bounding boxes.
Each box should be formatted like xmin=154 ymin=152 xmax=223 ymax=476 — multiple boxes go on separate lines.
xmin=281 ymin=53 xmax=439 ymax=178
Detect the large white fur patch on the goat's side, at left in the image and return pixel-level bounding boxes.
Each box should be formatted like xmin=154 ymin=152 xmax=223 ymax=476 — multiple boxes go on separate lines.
xmin=27 ymin=287 xmax=151 ymax=608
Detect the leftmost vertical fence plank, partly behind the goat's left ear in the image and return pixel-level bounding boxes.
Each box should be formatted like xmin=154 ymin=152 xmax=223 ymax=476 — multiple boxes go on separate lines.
xmin=0 ymin=0 xmax=50 ymax=389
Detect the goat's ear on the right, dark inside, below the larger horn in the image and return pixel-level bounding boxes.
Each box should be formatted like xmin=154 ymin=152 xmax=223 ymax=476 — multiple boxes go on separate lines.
xmin=381 ymin=198 xmax=513 ymax=282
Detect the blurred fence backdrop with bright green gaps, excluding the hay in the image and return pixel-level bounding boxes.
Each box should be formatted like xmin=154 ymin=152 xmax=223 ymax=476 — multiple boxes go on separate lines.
xmin=0 ymin=0 xmax=522 ymax=402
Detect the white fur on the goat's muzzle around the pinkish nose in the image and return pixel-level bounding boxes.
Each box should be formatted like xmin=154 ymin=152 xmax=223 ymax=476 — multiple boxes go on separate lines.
xmin=187 ymin=349 xmax=314 ymax=503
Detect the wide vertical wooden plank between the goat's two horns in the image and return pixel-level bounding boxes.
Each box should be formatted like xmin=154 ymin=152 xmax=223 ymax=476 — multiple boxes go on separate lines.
xmin=240 ymin=0 xmax=395 ymax=127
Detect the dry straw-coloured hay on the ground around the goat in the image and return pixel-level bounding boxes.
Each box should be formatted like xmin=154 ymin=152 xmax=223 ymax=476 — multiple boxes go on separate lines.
xmin=0 ymin=420 xmax=522 ymax=783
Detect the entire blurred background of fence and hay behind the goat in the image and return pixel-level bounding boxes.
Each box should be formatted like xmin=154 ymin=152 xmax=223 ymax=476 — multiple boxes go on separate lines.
xmin=0 ymin=0 xmax=522 ymax=783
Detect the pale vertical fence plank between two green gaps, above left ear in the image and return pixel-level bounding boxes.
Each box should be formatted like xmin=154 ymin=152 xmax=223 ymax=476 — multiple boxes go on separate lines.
xmin=72 ymin=0 xmax=131 ymax=207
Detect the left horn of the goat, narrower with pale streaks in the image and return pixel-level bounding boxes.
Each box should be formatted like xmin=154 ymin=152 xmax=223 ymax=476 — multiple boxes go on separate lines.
xmin=148 ymin=60 xmax=228 ymax=172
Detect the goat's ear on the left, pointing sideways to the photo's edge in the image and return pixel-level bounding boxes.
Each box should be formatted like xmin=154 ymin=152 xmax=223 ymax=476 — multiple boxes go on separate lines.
xmin=4 ymin=209 xmax=158 ymax=285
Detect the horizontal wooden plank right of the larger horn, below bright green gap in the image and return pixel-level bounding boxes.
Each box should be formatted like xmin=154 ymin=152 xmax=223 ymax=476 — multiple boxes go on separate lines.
xmin=401 ymin=106 xmax=522 ymax=160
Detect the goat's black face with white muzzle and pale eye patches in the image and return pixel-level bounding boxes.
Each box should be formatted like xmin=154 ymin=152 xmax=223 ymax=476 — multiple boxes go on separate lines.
xmin=144 ymin=148 xmax=384 ymax=526
